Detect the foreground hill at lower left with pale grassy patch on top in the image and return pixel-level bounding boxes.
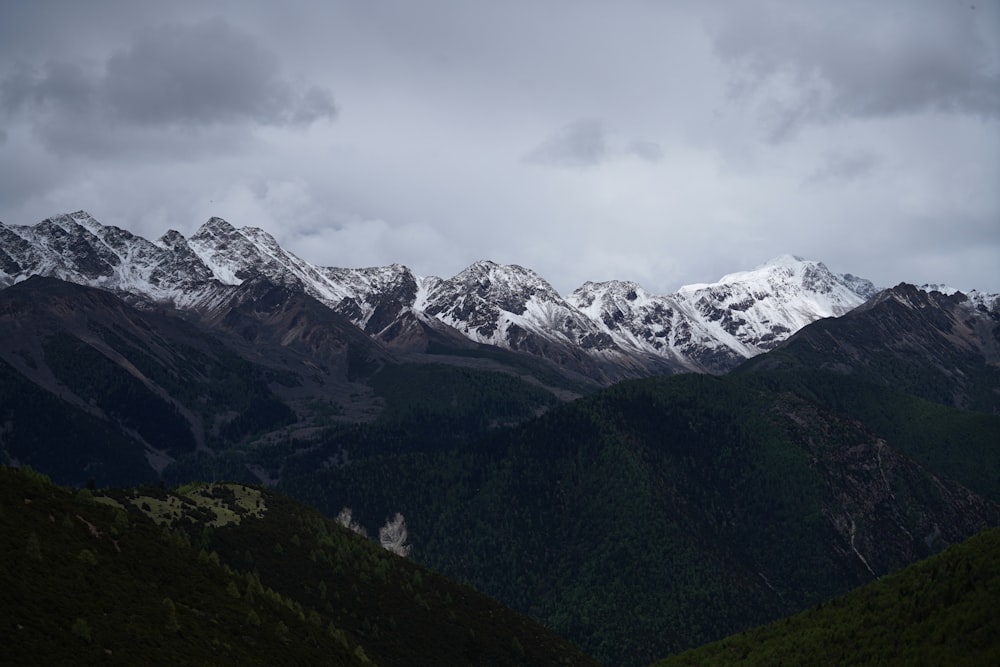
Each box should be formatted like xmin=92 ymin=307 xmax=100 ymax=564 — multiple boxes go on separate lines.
xmin=0 ymin=468 xmax=594 ymax=665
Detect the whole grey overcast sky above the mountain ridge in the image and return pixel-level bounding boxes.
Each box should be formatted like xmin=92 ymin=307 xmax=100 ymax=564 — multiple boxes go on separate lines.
xmin=0 ymin=0 xmax=1000 ymax=294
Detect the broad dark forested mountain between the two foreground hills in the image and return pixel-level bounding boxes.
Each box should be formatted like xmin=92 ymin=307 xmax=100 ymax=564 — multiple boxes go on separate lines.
xmin=278 ymin=376 xmax=1000 ymax=664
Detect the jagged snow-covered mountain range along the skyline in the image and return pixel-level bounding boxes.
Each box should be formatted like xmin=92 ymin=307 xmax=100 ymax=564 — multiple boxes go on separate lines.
xmin=0 ymin=211 xmax=908 ymax=384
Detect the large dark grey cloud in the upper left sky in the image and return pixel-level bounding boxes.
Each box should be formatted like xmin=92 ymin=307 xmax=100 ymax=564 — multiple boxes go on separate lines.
xmin=0 ymin=18 xmax=337 ymax=154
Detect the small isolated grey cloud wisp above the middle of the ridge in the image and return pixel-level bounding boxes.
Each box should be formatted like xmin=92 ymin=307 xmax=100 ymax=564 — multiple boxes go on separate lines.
xmin=524 ymin=118 xmax=663 ymax=169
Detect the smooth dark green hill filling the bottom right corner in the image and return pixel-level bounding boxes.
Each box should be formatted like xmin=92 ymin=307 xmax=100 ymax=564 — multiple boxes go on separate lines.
xmin=656 ymin=528 xmax=1000 ymax=667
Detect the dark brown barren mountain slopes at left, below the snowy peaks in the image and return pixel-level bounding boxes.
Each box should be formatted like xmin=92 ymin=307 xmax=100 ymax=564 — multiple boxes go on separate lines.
xmin=0 ymin=278 xmax=396 ymax=484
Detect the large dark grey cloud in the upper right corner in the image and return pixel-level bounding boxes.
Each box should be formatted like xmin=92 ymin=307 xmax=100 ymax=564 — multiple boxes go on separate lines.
xmin=714 ymin=2 xmax=1000 ymax=141
